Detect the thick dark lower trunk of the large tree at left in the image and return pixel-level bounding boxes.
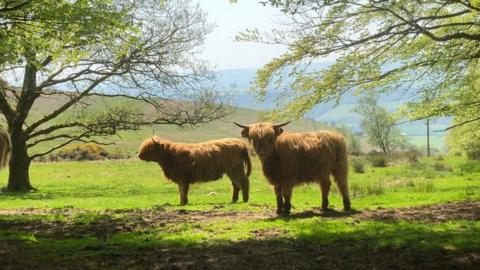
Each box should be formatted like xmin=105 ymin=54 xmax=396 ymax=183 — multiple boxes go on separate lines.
xmin=5 ymin=132 xmax=34 ymax=192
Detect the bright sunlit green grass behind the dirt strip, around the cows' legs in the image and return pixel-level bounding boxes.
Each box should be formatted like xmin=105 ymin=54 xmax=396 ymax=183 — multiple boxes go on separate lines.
xmin=0 ymin=157 xmax=480 ymax=211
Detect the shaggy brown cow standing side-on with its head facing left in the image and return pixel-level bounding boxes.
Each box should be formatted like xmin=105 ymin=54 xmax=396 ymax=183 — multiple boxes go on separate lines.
xmin=138 ymin=136 xmax=252 ymax=205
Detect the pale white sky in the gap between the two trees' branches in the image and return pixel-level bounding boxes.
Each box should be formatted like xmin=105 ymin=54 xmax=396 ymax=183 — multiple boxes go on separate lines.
xmin=197 ymin=0 xmax=286 ymax=70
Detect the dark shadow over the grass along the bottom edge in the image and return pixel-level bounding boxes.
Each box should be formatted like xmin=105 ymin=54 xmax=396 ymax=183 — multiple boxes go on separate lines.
xmin=0 ymin=225 xmax=480 ymax=269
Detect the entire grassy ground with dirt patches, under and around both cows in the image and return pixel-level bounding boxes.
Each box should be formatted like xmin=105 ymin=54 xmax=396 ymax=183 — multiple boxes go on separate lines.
xmin=0 ymin=157 xmax=480 ymax=269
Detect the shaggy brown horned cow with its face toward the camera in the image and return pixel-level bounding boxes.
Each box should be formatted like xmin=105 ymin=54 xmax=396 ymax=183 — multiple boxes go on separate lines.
xmin=234 ymin=122 xmax=350 ymax=214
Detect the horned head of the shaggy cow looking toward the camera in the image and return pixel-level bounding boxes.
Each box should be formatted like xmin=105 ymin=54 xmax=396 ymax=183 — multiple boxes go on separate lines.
xmin=233 ymin=122 xmax=290 ymax=158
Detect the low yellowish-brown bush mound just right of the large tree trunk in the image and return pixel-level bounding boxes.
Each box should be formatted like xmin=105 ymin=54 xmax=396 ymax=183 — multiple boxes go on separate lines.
xmin=36 ymin=143 xmax=126 ymax=162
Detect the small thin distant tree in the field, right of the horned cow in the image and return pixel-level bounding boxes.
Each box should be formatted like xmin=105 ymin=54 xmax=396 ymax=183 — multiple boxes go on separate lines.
xmin=355 ymin=92 xmax=406 ymax=154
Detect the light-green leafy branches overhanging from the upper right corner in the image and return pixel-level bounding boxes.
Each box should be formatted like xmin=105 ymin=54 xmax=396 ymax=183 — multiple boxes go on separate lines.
xmin=242 ymin=0 xmax=480 ymax=127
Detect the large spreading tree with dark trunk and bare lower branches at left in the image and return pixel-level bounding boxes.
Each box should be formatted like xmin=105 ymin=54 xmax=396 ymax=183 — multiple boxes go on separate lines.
xmin=0 ymin=0 xmax=229 ymax=191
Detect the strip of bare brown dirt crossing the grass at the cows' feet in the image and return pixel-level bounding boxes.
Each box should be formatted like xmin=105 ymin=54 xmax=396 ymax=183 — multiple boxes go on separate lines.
xmin=0 ymin=202 xmax=480 ymax=238
